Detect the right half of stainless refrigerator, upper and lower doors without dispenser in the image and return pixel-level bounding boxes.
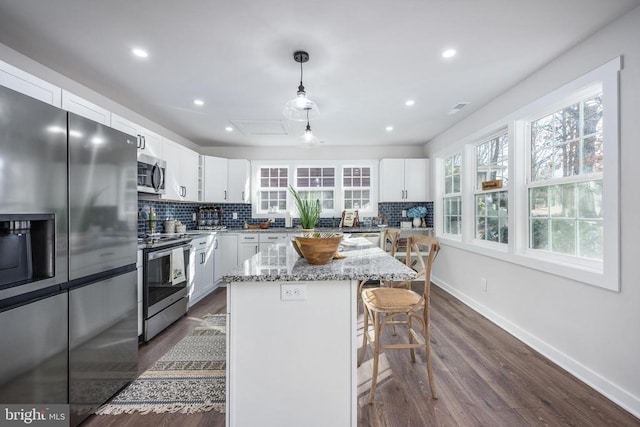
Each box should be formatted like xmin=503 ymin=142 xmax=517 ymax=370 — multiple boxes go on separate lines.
xmin=64 ymin=113 xmax=138 ymax=425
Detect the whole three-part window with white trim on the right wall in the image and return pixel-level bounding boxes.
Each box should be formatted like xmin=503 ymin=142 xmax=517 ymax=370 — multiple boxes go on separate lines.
xmin=431 ymin=57 xmax=622 ymax=291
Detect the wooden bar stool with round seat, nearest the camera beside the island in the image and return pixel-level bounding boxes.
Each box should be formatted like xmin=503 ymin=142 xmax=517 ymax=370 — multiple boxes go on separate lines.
xmin=358 ymin=235 xmax=440 ymax=403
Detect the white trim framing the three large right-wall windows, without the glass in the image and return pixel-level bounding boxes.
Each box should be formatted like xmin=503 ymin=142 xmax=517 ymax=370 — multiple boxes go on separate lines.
xmin=434 ymin=57 xmax=622 ymax=292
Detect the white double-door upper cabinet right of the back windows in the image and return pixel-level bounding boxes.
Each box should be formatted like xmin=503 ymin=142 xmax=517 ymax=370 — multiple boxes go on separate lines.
xmin=380 ymin=159 xmax=429 ymax=202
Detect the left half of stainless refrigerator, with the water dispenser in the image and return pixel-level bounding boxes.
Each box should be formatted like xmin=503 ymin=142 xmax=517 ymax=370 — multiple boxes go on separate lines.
xmin=0 ymin=86 xmax=68 ymax=404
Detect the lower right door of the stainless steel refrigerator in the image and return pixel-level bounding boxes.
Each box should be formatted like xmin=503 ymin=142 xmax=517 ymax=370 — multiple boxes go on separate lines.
xmin=69 ymin=270 xmax=138 ymax=426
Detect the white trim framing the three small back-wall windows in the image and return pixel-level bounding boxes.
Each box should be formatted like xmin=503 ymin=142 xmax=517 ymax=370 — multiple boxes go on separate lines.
xmin=251 ymin=159 xmax=380 ymax=218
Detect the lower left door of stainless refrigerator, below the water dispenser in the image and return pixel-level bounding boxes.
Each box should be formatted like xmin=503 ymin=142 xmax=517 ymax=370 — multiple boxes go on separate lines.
xmin=0 ymin=292 xmax=67 ymax=404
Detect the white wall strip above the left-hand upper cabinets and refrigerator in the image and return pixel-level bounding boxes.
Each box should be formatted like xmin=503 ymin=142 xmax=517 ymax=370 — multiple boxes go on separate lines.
xmin=0 ymin=43 xmax=200 ymax=151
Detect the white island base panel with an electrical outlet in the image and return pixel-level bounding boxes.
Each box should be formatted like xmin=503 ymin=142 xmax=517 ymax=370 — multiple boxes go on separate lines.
xmin=226 ymin=280 xmax=358 ymax=427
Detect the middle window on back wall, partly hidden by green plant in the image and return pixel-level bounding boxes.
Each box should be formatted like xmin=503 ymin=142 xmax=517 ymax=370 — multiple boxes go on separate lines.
xmin=296 ymin=167 xmax=336 ymax=211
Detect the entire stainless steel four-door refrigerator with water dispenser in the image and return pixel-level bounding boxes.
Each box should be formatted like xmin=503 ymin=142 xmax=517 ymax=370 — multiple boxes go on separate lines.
xmin=0 ymin=86 xmax=138 ymax=426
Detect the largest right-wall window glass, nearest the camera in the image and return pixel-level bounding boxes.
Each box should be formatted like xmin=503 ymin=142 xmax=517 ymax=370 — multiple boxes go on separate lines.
xmin=528 ymin=89 xmax=604 ymax=260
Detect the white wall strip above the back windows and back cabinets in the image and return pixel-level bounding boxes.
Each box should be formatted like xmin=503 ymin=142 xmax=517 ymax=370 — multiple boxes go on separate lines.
xmin=200 ymin=145 xmax=424 ymax=160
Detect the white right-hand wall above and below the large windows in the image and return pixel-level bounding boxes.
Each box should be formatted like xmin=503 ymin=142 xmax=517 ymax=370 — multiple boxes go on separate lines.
xmin=425 ymin=4 xmax=640 ymax=417
